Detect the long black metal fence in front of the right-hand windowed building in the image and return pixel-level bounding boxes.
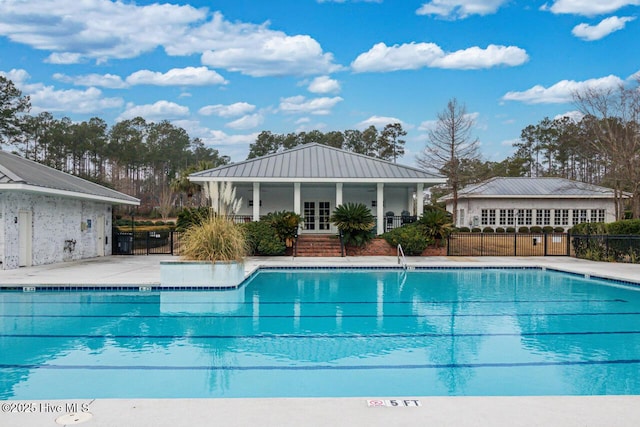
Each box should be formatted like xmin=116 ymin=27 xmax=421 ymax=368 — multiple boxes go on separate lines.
xmin=447 ymin=233 xmax=571 ymax=256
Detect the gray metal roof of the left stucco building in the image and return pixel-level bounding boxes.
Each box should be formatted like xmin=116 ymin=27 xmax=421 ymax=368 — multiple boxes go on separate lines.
xmin=0 ymin=150 xmax=140 ymax=205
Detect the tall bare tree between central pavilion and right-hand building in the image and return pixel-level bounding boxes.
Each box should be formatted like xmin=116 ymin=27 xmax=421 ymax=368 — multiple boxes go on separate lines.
xmin=416 ymin=98 xmax=480 ymax=224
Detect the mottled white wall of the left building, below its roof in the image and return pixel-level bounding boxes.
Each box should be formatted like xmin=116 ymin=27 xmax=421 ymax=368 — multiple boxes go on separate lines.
xmin=0 ymin=192 xmax=111 ymax=269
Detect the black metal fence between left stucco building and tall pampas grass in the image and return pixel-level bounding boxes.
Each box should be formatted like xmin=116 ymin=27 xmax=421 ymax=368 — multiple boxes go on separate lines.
xmin=112 ymin=230 xmax=182 ymax=255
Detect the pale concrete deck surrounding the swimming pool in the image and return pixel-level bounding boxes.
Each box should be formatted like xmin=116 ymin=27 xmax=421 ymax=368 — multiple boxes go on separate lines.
xmin=0 ymin=255 xmax=640 ymax=427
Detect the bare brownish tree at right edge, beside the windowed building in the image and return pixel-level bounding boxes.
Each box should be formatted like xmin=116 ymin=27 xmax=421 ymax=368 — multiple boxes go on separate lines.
xmin=573 ymin=79 xmax=640 ymax=219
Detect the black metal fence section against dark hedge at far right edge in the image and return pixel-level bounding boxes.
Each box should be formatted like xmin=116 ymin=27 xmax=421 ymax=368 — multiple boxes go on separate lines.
xmin=571 ymin=234 xmax=640 ymax=264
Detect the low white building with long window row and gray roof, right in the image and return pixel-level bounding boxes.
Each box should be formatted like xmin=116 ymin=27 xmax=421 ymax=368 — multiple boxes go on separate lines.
xmin=439 ymin=178 xmax=616 ymax=231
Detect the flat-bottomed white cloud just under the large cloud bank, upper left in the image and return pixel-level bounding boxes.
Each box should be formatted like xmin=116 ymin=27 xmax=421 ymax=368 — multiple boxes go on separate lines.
xmin=127 ymin=67 xmax=228 ymax=86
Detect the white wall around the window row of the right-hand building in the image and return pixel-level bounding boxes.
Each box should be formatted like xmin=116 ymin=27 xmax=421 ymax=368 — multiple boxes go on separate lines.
xmin=446 ymin=198 xmax=615 ymax=229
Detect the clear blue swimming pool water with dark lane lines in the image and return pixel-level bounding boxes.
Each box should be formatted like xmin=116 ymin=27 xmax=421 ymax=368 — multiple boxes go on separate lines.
xmin=0 ymin=269 xmax=640 ymax=399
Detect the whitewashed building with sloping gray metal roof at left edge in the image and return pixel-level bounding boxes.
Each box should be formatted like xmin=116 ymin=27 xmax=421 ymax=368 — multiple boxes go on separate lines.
xmin=0 ymin=151 xmax=140 ymax=269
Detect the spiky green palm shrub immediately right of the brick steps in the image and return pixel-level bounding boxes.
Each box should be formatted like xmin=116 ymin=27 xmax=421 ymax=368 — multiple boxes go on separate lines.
xmin=331 ymin=203 xmax=375 ymax=246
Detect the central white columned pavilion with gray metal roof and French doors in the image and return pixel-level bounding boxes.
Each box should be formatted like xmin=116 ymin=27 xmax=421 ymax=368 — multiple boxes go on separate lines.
xmin=189 ymin=143 xmax=445 ymax=234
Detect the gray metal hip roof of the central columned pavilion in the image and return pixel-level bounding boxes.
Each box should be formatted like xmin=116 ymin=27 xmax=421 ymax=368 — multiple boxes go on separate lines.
xmin=189 ymin=143 xmax=445 ymax=183
